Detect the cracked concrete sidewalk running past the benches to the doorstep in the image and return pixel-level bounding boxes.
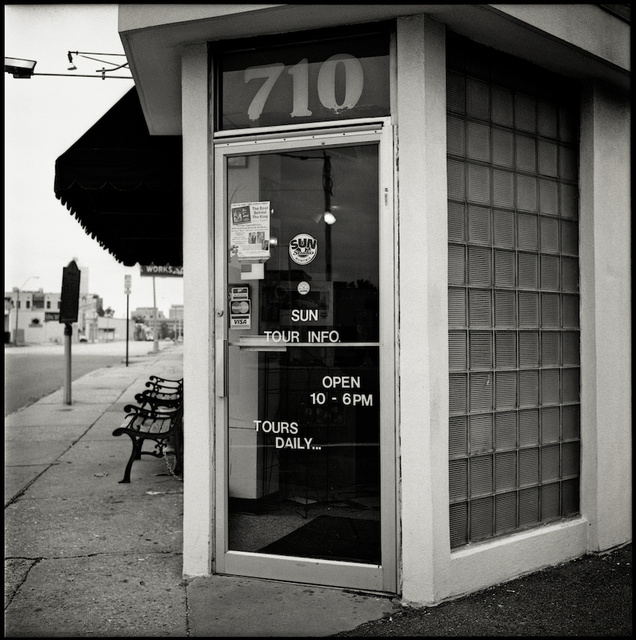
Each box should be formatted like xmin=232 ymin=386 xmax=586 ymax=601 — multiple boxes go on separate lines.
xmin=5 ymin=345 xmax=400 ymax=637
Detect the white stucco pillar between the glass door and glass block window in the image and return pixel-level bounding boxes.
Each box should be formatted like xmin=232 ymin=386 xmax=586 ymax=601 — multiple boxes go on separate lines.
xmin=397 ymin=15 xmax=449 ymax=602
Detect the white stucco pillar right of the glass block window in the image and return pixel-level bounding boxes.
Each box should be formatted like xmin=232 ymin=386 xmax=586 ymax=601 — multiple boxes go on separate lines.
xmin=580 ymin=79 xmax=632 ymax=550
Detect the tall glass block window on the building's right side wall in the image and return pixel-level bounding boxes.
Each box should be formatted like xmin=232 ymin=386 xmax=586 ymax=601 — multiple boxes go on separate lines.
xmin=447 ymin=34 xmax=580 ymax=548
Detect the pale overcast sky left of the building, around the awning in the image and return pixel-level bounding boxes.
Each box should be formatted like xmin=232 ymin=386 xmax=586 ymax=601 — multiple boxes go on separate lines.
xmin=4 ymin=4 xmax=183 ymax=318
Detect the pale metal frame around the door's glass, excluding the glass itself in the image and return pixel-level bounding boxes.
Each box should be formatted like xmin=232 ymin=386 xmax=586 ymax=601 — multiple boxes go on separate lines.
xmin=213 ymin=118 xmax=398 ymax=593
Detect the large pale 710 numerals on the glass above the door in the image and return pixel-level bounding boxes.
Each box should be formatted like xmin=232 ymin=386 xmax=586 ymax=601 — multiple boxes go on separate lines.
xmin=245 ymin=53 xmax=364 ymax=120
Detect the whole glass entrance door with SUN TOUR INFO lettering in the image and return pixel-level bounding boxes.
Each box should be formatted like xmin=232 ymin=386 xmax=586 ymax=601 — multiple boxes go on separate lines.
xmin=215 ymin=122 xmax=395 ymax=591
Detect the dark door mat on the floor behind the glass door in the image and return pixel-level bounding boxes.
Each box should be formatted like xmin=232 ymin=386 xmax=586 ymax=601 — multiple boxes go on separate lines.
xmin=259 ymin=516 xmax=380 ymax=564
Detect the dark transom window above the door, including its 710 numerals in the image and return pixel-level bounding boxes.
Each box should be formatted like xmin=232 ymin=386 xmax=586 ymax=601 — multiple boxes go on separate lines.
xmin=214 ymin=23 xmax=390 ymax=131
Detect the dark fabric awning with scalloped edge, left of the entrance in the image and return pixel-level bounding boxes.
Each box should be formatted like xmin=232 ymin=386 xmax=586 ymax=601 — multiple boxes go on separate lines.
xmin=55 ymin=88 xmax=183 ymax=266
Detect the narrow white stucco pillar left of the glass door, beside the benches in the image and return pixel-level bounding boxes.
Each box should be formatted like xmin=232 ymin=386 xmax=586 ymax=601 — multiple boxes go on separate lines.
xmin=182 ymin=44 xmax=214 ymax=576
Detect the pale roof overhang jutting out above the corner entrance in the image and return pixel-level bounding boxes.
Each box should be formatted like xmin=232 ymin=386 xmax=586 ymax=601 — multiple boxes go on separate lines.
xmin=119 ymin=4 xmax=631 ymax=135
